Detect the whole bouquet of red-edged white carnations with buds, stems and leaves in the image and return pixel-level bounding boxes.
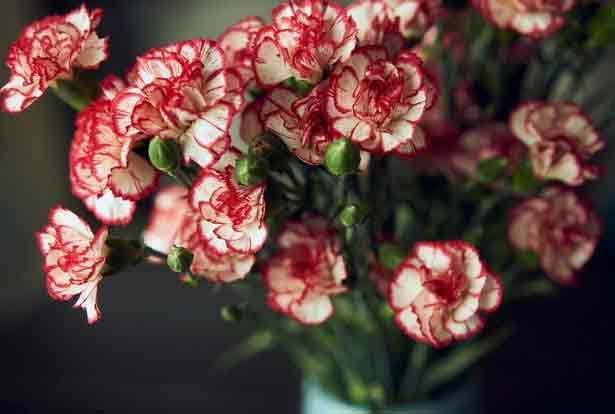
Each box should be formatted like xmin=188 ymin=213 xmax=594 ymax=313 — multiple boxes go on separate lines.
xmin=0 ymin=0 xmax=615 ymax=412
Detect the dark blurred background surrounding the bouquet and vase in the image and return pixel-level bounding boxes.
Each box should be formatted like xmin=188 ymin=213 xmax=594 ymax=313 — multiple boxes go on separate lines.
xmin=0 ymin=0 xmax=615 ymax=414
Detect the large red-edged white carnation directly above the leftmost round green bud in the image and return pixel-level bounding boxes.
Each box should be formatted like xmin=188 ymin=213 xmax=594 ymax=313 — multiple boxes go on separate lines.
xmin=111 ymin=39 xmax=233 ymax=168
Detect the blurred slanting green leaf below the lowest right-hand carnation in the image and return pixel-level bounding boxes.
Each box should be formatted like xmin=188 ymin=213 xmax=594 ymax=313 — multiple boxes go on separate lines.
xmin=421 ymin=327 xmax=514 ymax=393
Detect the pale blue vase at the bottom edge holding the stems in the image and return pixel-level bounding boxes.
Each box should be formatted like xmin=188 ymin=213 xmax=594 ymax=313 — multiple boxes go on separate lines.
xmin=302 ymin=379 xmax=483 ymax=414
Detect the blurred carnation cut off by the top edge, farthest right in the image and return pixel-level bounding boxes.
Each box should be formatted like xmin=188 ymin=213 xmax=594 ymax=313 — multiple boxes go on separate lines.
xmin=471 ymin=0 xmax=575 ymax=38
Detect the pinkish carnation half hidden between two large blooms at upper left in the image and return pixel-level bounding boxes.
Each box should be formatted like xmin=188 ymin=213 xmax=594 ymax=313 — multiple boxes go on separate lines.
xmin=218 ymin=16 xmax=265 ymax=85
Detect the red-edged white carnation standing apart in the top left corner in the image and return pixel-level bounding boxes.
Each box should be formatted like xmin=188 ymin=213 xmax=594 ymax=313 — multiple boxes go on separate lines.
xmin=0 ymin=5 xmax=107 ymax=112
